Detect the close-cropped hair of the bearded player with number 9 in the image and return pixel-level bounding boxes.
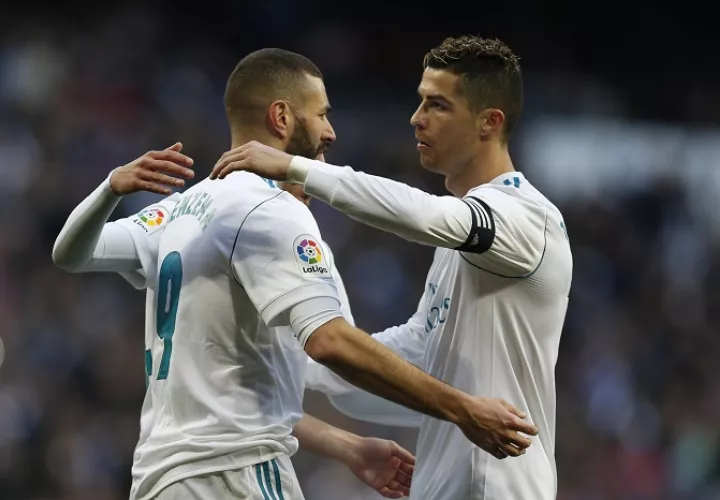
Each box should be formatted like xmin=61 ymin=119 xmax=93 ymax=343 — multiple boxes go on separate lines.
xmin=225 ymin=48 xmax=323 ymax=125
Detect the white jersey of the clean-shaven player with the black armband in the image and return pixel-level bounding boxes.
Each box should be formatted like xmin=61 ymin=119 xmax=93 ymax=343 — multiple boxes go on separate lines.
xmin=375 ymin=173 xmax=572 ymax=500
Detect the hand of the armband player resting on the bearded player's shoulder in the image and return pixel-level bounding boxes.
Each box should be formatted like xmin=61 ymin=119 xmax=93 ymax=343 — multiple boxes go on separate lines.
xmin=210 ymin=141 xmax=292 ymax=181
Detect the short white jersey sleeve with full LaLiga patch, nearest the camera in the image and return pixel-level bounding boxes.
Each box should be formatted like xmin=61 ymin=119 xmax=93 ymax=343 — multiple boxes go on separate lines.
xmin=231 ymin=196 xmax=340 ymax=346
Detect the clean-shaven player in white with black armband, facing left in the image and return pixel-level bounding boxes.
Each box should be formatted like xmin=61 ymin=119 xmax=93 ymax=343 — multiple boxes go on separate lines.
xmin=211 ymin=36 xmax=572 ymax=500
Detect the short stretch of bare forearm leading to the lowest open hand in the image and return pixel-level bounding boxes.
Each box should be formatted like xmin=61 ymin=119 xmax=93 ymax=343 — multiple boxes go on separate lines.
xmin=293 ymin=414 xmax=362 ymax=463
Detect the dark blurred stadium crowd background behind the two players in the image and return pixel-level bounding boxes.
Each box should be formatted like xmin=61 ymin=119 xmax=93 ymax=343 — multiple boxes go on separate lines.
xmin=0 ymin=0 xmax=720 ymax=500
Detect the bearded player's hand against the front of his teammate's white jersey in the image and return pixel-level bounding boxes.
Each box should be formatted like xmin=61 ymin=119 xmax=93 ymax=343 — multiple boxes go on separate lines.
xmin=458 ymin=398 xmax=538 ymax=459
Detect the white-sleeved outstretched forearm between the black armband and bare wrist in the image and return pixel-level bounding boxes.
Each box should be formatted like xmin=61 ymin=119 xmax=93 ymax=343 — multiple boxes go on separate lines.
xmin=288 ymin=157 xmax=472 ymax=248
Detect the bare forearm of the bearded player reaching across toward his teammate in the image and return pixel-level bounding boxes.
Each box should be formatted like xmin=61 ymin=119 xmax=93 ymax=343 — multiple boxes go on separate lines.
xmin=305 ymin=319 xmax=468 ymax=422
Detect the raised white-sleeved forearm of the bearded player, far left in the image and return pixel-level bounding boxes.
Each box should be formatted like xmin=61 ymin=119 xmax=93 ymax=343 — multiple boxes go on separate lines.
xmin=52 ymin=173 xmax=121 ymax=271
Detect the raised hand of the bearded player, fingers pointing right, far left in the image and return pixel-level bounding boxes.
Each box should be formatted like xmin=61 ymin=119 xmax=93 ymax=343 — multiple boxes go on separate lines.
xmin=110 ymin=142 xmax=195 ymax=195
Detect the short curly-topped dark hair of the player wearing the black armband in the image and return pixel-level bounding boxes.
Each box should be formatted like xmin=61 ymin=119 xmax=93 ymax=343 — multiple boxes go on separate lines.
xmin=423 ymin=35 xmax=523 ymax=139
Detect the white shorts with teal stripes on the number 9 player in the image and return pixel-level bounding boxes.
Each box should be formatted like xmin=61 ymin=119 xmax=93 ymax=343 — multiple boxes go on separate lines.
xmin=153 ymin=455 xmax=305 ymax=500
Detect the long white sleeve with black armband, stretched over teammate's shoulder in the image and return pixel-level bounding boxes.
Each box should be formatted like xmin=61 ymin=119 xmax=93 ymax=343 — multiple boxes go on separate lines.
xmin=288 ymin=156 xmax=547 ymax=278
